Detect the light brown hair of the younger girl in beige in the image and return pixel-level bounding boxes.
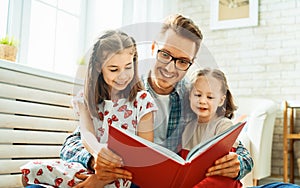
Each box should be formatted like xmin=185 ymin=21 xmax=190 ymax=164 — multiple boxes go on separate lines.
xmin=192 ymin=68 xmax=237 ymax=119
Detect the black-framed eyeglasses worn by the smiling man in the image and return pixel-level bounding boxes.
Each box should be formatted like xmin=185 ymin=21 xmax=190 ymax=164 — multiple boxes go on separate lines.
xmin=156 ymin=50 xmax=193 ymax=71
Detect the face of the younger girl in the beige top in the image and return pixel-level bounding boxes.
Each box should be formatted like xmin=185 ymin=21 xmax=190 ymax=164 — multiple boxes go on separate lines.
xmin=190 ymin=75 xmax=226 ymax=123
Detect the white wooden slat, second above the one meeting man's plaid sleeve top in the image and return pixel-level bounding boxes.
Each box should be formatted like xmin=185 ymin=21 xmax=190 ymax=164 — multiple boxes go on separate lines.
xmin=0 ymin=99 xmax=76 ymax=119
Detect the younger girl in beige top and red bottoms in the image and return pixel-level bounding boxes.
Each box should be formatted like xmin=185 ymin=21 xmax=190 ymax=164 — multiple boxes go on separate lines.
xmin=181 ymin=69 xmax=240 ymax=187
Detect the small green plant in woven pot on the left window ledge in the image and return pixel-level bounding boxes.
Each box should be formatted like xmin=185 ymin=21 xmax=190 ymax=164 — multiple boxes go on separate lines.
xmin=0 ymin=36 xmax=17 ymax=61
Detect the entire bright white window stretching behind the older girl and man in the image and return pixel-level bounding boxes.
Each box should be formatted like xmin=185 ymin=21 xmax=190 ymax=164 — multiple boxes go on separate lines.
xmin=0 ymin=0 xmax=170 ymax=76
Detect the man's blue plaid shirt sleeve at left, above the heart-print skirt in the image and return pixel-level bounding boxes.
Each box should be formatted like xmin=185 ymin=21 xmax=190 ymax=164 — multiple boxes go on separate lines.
xmin=60 ymin=128 xmax=93 ymax=170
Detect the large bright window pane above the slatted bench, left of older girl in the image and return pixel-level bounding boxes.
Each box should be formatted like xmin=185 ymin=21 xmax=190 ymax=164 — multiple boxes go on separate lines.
xmin=21 ymin=0 xmax=84 ymax=75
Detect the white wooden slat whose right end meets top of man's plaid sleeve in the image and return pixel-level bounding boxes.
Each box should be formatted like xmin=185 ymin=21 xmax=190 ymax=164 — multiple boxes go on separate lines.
xmin=0 ymin=129 xmax=69 ymax=144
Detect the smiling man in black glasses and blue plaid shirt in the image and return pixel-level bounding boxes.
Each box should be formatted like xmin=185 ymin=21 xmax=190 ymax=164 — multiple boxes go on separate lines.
xmin=61 ymin=15 xmax=253 ymax=187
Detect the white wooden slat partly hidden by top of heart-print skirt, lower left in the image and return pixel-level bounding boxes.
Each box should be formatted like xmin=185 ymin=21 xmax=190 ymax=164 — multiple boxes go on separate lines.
xmin=0 ymin=158 xmax=59 ymax=174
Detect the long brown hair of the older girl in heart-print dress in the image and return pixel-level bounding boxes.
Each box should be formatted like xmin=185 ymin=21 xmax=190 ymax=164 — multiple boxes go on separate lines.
xmin=84 ymin=30 xmax=143 ymax=117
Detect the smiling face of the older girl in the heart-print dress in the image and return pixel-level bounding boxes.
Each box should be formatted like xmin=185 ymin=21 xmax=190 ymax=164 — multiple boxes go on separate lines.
xmin=102 ymin=49 xmax=134 ymax=92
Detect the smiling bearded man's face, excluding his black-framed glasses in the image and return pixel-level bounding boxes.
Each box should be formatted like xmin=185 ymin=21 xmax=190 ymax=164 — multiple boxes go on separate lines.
xmin=151 ymin=29 xmax=196 ymax=94
